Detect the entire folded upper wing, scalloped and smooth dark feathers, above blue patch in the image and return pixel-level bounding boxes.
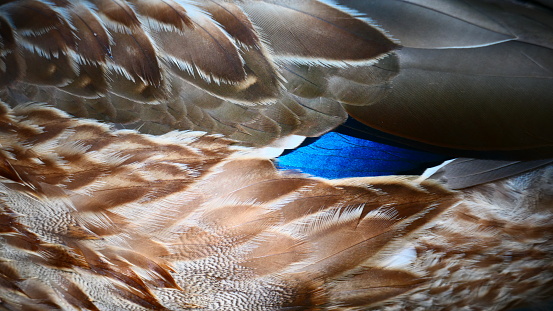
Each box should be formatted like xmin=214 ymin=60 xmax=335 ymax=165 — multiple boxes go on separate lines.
xmin=0 ymin=0 xmax=553 ymax=156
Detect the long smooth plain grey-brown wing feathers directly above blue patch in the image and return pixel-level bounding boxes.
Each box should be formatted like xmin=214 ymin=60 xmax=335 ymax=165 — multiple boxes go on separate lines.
xmin=344 ymin=1 xmax=553 ymax=159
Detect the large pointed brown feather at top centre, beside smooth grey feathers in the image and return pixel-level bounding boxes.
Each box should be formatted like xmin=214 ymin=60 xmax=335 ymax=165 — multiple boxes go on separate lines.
xmin=237 ymin=1 xmax=397 ymax=62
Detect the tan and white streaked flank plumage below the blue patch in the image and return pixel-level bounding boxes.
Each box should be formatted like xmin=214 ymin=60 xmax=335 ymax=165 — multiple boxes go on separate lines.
xmin=0 ymin=105 xmax=553 ymax=310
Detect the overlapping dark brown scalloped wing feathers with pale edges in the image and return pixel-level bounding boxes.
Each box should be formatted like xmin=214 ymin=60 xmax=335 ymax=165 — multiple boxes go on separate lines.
xmin=0 ymin=0 xmax=397 ymax=145
